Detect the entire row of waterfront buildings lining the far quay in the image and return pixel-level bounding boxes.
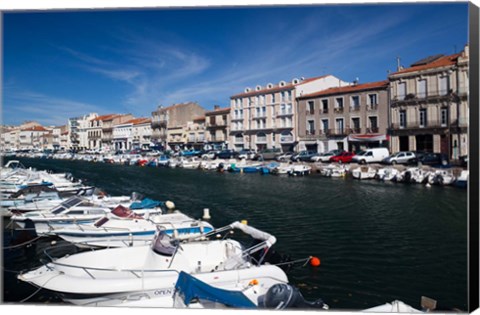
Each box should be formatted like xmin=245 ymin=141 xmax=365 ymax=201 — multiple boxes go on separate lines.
xmin=1 ymin=46 xmax=469 ymax=160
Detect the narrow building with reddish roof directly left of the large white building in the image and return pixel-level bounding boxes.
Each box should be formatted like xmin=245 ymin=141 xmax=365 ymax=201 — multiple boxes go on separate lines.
xmin=205 ymin=105 xmax=231 ymax=149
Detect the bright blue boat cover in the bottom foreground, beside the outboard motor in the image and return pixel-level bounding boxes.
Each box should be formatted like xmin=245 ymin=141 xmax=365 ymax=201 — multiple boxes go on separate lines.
xmin=175 ymin=271 xmax=257 ymax=308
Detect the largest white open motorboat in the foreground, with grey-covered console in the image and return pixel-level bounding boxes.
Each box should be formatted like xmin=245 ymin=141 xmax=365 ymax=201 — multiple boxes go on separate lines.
xmin=18 ymin=222 xmax=288 ymax=307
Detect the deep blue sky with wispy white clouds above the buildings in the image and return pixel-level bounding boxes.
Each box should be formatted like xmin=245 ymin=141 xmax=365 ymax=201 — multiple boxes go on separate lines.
xmin=2 ymin=2 xmax=468 ymax=125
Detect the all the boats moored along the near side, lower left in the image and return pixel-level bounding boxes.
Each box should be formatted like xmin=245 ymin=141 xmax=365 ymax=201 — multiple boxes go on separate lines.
xmin=0 ymin=161 xmax=440 ymax=312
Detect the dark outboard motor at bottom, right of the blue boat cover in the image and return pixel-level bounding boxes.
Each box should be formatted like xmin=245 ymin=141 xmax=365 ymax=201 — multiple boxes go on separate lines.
xmin=263 ymin=283 xmax=328 ymax=310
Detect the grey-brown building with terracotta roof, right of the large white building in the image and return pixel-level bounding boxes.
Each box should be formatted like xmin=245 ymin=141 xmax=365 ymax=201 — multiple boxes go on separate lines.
xmin=297 ymin=81 xmax=388 ymax=152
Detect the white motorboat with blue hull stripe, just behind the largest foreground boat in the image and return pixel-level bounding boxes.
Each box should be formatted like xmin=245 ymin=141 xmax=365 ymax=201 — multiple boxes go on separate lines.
xmin=50 ymin=210 xmax=213 ymax=247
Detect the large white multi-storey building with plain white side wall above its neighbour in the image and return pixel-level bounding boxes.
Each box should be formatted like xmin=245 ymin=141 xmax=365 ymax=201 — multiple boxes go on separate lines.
xmin=230 ymin=75 xmax=349 ymax=151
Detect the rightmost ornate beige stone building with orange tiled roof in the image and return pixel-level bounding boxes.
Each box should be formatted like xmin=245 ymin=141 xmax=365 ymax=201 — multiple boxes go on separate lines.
xmin=388 ymin=46 xmax=469 ymax=160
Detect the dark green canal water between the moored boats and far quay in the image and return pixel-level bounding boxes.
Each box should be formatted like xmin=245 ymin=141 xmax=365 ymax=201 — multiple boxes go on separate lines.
xmin=3 ymin=159 xmax=468 ymax=310
